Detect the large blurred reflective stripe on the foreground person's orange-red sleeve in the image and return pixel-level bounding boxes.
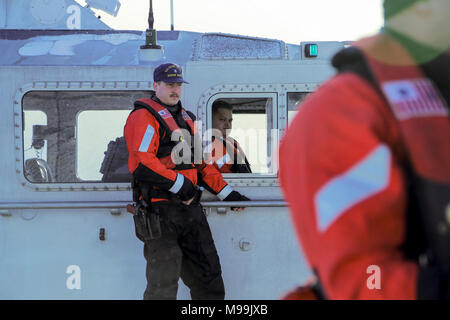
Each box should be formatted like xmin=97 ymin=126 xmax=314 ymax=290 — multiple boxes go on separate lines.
xmin=314 ymin=145 xmax=391 ymax=232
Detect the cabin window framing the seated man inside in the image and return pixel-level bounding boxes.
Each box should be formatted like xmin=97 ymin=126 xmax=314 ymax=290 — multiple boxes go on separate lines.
xmin=204 ymin=94 xmax=278 ymax=175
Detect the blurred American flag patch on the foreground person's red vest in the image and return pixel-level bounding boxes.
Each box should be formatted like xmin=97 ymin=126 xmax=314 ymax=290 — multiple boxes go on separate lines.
xmin=383 ymin=78 xmax=448 ymax=120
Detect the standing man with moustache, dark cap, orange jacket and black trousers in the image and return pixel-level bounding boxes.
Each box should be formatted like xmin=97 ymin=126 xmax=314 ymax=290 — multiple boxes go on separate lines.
xmin=124 ymin=63 xmax=250 ymax=299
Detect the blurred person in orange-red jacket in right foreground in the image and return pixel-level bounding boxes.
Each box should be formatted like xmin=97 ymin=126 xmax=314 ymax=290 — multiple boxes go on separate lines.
xmin=280 ymin=0 xmax=450 ymax=299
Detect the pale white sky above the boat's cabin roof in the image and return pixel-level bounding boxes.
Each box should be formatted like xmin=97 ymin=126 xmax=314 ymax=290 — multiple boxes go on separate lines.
xmin=76 ymin=0 xmax=382 ymax=44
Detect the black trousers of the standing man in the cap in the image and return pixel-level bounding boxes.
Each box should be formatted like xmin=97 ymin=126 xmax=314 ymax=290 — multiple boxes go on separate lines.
xmin=144 ymin=201 xmax=225 ymax=300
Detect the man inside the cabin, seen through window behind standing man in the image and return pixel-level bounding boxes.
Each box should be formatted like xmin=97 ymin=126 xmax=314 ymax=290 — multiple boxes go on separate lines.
xmin=211 ymin=99 xmax=252 ymax=173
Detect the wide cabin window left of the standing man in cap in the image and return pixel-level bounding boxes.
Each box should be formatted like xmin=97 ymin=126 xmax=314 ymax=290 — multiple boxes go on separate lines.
xmin=22 ymin=91 xmax=151 ymax=183
